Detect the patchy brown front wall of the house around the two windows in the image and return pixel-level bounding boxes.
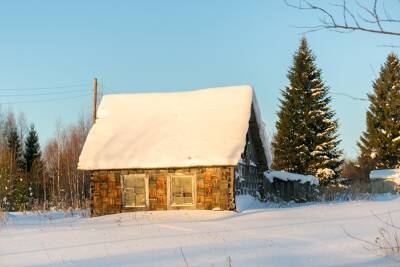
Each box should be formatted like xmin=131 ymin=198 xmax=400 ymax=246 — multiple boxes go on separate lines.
xmin=90 ymin=166 xmax=235 ymax=216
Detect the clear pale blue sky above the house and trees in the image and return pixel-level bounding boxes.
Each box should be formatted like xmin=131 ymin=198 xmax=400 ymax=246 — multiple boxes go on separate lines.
xmin=0 ymin=0 xmax=400 ymax=157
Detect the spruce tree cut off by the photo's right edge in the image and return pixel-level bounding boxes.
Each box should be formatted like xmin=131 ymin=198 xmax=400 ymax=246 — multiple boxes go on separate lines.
xmin=358 ymin=53 xmax=400 ymax=168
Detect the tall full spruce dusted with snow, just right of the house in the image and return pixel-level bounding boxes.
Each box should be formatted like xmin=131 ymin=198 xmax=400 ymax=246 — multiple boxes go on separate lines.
xmin=272 ymin=38 xmax=342 ymax=183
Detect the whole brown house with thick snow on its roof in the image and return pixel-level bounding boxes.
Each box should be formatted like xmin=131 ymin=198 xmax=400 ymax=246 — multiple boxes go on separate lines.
xmin=78 ymin=86 xmax=270 ymax=216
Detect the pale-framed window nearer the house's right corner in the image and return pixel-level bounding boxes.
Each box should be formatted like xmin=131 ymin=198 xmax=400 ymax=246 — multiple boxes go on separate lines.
xmin=170 ymin=175 xmax=195 ymax=206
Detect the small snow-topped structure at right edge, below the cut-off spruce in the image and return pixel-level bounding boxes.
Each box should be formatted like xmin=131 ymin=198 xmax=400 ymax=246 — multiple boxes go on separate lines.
xmin=369 ymin=169 xmax=400 ymax=194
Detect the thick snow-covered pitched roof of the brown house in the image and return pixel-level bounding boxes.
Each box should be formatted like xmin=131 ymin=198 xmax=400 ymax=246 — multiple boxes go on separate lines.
xmin=78 ymin=85 xmax=270 ymax=170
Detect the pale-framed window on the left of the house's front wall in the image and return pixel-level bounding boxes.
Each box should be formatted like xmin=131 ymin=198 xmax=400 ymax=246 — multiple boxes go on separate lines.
xmin=122 ymin=174 xmax=148 ymax=207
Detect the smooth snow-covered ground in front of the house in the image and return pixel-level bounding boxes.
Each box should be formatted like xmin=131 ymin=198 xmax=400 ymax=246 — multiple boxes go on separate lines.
xmin=0 ymin=197 xmax=400 ymax=267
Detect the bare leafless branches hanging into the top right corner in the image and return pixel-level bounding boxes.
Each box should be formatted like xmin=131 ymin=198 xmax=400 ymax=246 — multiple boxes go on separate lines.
xmin=285 ymin=0 xmax=400 ymax=36
